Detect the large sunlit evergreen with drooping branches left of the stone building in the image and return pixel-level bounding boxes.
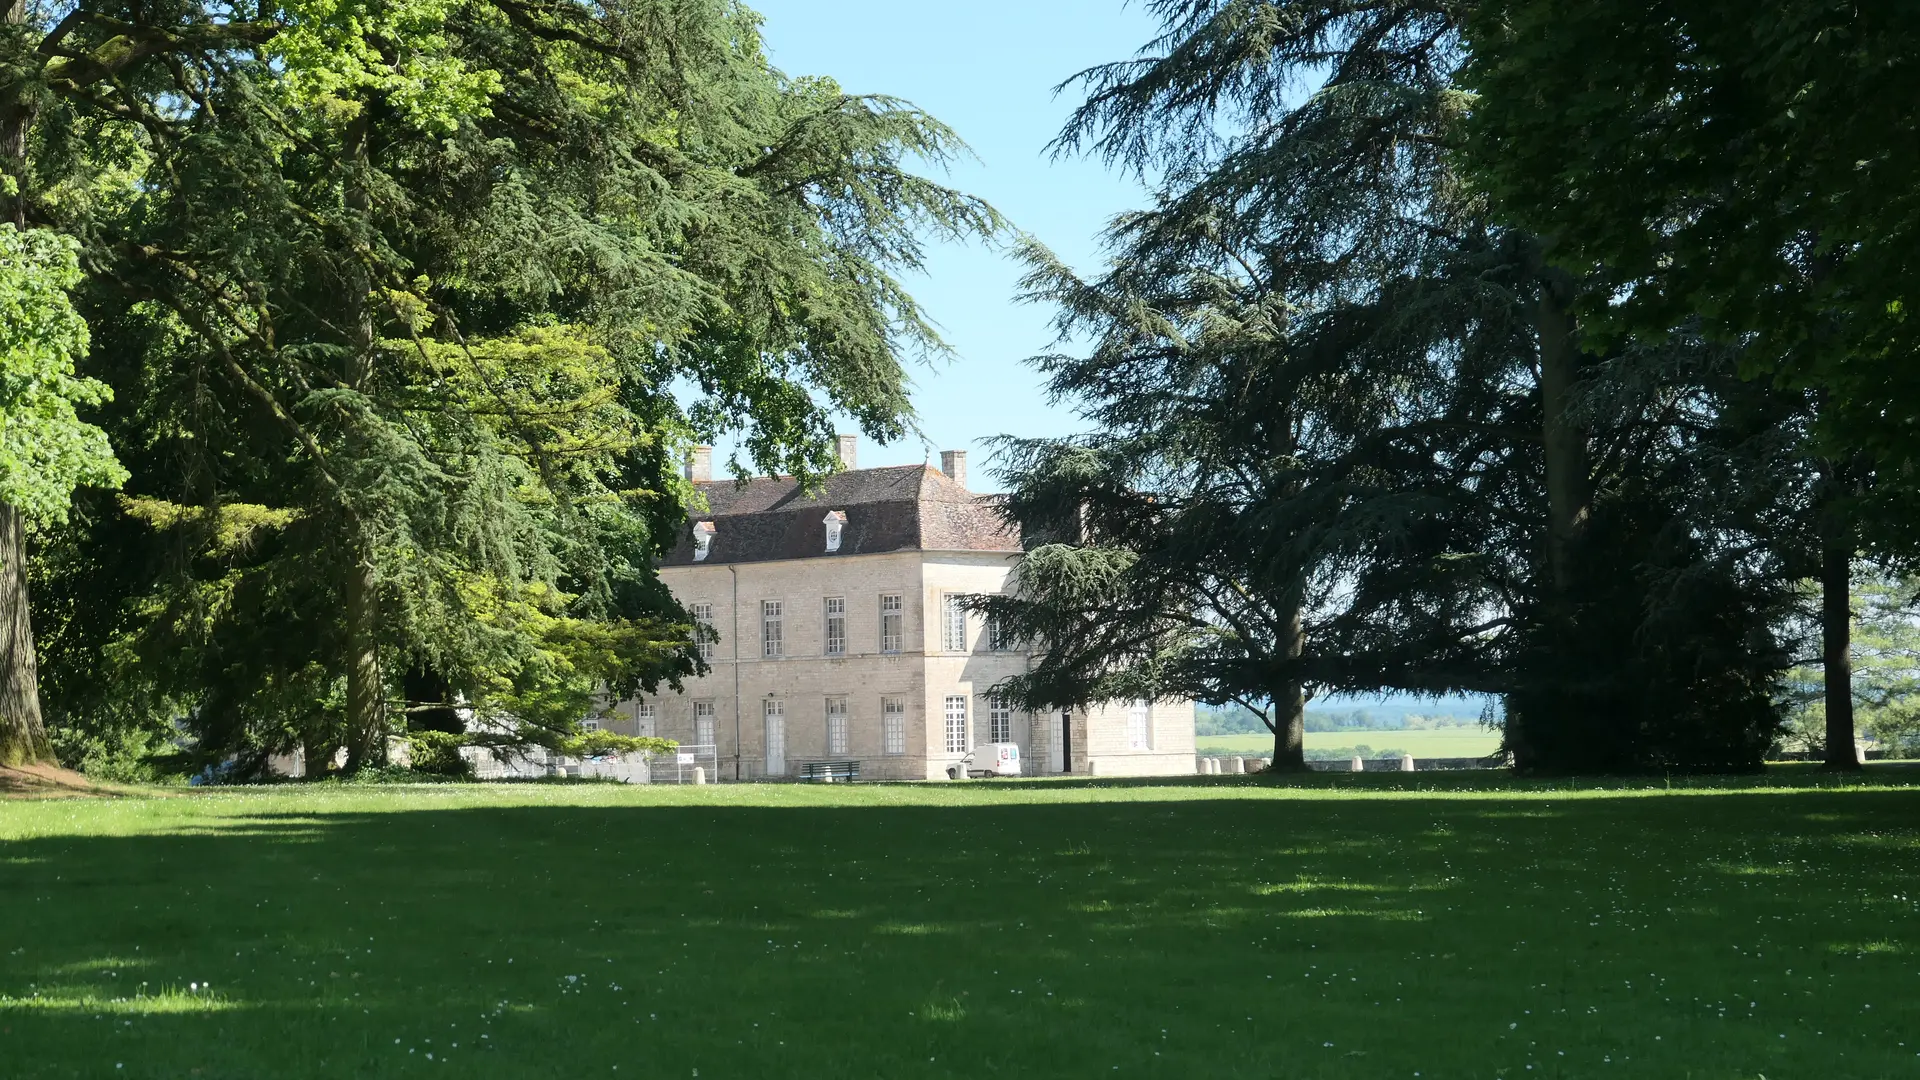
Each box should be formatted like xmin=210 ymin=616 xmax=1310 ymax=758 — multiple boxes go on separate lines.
xmin=11 ymin=0 xmax=998 ymax=769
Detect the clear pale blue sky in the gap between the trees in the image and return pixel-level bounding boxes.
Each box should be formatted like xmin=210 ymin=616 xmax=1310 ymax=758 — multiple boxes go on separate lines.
xmin=718 ymin=0 xmax=1154 ymax=492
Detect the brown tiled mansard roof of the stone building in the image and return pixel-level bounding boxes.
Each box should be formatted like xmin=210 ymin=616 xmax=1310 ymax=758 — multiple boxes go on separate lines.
xmin=660 ymin=465 xmax=1020 ymax=567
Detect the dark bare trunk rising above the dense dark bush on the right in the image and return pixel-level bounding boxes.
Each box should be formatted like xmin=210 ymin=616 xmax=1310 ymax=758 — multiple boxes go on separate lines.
xmin=1534 ymin=267 xmax=1594 ymax=598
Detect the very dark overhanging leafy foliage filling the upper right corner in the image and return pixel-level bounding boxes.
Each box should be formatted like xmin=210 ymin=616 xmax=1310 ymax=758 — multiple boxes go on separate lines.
xmin=1465 ymin=0 xmax=1920 ymax=552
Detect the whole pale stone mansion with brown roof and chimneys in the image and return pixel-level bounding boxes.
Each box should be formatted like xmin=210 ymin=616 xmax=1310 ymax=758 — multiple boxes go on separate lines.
xmin=609 ymin=436 xmax=1194 ymax=780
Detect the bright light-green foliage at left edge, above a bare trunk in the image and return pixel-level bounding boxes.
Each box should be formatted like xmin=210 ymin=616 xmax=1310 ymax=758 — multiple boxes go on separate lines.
xmin=0 ymin=223 xmax=127 ymax=523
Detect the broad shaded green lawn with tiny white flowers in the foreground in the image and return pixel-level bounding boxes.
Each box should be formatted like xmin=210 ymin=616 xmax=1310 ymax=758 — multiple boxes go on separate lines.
xmin=0 ymin=771 xmax=1920 ymax=1080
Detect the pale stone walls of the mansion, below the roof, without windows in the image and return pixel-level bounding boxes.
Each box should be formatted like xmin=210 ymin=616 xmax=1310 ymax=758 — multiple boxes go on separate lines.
xmin=633 ymin=552 xmax=1194 ymax=780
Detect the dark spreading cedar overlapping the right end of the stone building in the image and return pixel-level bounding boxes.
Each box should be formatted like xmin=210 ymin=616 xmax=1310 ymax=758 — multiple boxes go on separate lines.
xmin=987 ymin=0 xmax=1799 ymax=771
